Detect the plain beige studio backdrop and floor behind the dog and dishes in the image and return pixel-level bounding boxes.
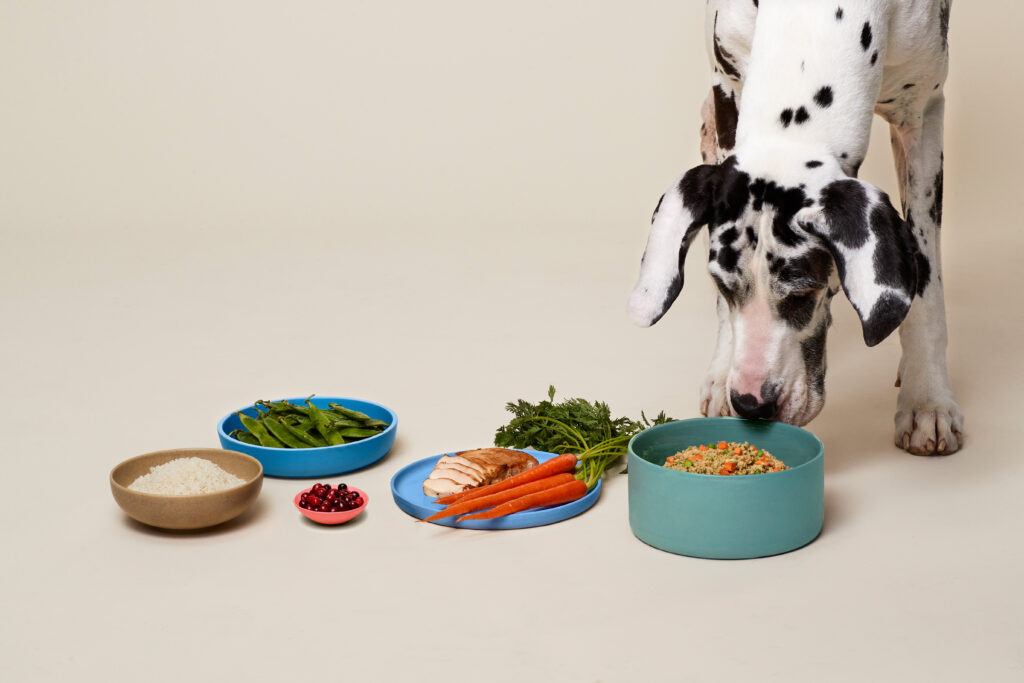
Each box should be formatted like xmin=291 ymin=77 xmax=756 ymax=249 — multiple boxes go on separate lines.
xmin=0 ymin=0 xmax=1024 ymax=681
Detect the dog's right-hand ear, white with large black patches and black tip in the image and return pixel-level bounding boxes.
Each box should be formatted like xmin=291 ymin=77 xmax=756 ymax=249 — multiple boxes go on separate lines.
xmin=797 ymin=178 xmax=920 ymax=346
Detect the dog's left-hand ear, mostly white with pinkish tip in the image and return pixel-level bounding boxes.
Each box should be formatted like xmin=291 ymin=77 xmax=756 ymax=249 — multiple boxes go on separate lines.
xmin=629 ymin=164 xmax=721 ymax=327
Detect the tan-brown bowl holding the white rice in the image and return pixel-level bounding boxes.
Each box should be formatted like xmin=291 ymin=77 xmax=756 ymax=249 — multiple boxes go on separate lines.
xmin=111 ymin=449 xmax=263 ymax=529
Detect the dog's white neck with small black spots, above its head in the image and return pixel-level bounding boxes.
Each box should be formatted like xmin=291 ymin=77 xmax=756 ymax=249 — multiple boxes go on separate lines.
xmin=736 ymin=0 xmax=888 ymax=176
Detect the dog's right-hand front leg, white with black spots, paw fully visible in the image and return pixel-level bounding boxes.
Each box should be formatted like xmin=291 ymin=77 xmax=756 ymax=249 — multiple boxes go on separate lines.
xmin=891 ymin=94 xmax=964 ymax=455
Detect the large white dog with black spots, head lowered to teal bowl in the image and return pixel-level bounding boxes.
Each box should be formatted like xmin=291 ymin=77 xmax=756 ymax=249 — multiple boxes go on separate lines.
xmin=629 ymin=0 xmax=964 ymax=455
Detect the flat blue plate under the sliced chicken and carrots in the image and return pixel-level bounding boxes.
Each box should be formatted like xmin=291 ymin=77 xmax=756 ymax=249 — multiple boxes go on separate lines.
xmin=391 ymin=449 xmax=601 ymax=529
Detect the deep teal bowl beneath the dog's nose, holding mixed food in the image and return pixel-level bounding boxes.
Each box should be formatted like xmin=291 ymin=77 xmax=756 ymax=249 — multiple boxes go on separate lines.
xmin=629 ymin=418 xmax=824 ymax=559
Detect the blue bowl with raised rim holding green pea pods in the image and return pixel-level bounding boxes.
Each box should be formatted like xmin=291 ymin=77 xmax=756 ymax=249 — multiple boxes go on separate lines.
xmin=217 ymin=396 xmax=398 ymax=478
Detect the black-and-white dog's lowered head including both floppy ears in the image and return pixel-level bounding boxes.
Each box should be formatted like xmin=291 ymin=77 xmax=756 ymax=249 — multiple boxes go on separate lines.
xmin=629 ymin=155 xmax=919 ymax=425
